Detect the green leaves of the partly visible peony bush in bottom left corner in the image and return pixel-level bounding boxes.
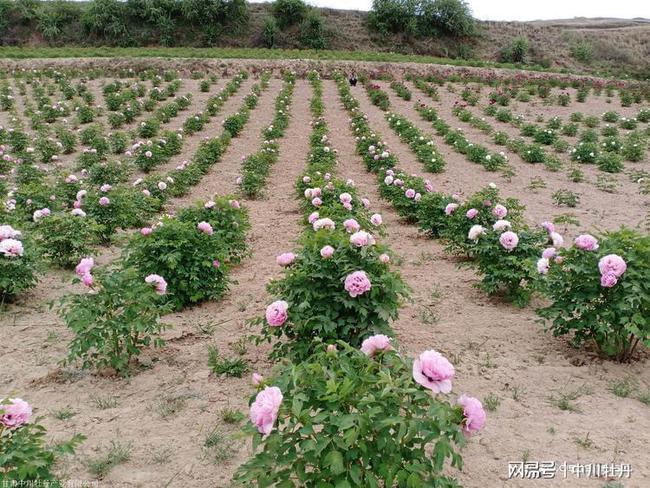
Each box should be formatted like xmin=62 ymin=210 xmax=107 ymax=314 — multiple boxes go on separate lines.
xmin=0 ymin=416 xmax=85 ymax=487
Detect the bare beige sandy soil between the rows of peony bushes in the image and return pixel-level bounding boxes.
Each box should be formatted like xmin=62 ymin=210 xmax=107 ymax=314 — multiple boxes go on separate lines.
xmin=0 ymin=73 xmax=650 ymax=488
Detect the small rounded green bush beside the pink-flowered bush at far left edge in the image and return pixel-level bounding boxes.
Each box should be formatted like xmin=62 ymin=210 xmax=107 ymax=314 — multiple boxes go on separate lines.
xmin=37 ymin=212 xmax=101 ymax=269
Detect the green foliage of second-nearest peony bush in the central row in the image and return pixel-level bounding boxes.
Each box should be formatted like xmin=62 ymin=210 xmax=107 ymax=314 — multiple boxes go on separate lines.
xmin=258 ymin=230 xmax=408 ymax=360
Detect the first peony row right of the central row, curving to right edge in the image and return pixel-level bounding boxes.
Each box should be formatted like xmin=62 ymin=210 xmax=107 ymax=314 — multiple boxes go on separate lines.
xmin=337 ymin=72 xmax=650 ymax=361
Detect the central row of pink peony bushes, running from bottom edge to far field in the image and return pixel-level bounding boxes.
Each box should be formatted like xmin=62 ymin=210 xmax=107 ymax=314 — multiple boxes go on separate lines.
xmin=235 ymin=73 xmax=486 ymax=487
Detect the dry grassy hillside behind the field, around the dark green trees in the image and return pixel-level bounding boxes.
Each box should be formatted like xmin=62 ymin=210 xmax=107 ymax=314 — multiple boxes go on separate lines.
xmin=0 ymin=2 xmax=650 ymax=78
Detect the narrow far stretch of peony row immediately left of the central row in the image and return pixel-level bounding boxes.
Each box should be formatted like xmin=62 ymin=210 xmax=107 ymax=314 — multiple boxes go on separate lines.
xmin=237 ymin=71 xmax=295 ymax=198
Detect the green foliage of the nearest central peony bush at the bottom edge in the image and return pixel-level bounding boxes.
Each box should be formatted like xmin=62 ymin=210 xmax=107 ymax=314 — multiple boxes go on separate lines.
xmin=235 ymin=341 xmax=465 ymax=488
